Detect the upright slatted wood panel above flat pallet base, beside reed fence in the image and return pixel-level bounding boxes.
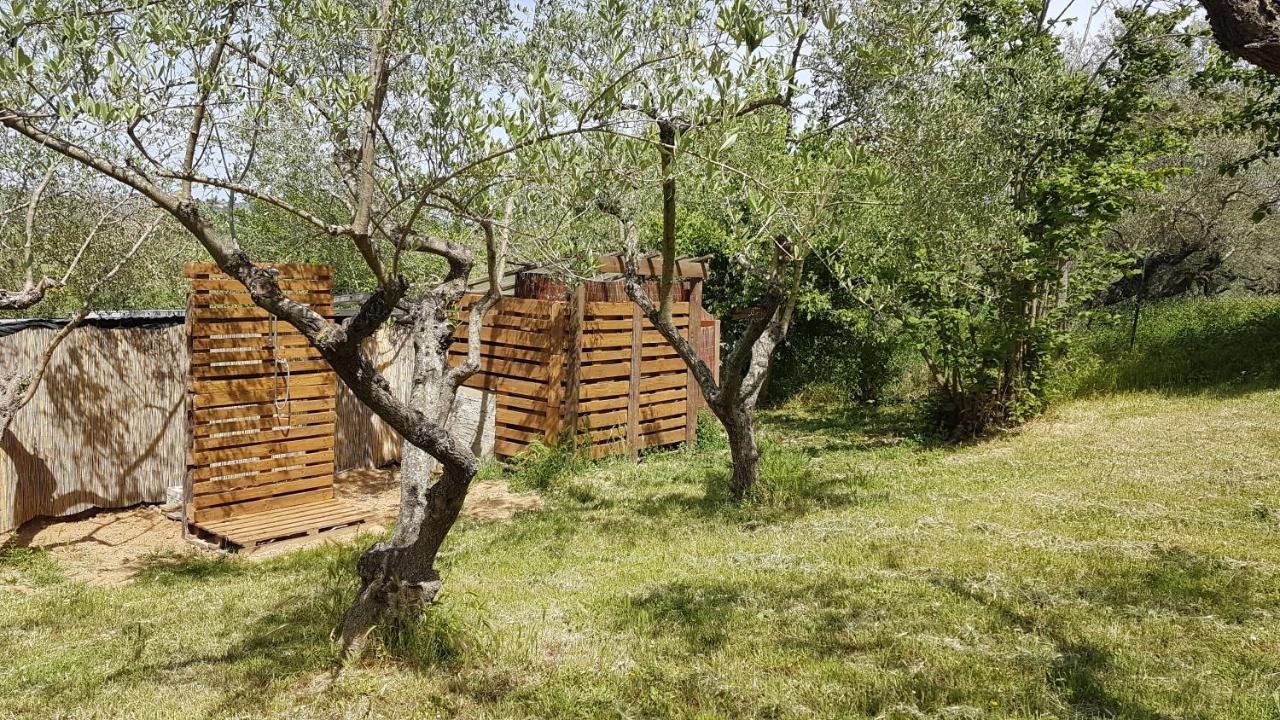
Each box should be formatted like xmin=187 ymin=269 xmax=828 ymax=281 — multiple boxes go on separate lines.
xmin=186 ymin=263 xmax=337 ymax=523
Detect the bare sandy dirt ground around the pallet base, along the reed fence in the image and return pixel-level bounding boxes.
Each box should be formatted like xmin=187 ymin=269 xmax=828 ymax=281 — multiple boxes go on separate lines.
xmin=0 ymin=470 xmax=540 ymax=585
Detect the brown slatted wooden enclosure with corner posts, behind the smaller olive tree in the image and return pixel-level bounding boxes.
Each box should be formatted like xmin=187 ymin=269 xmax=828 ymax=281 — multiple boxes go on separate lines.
xmin=451 ymin=278 xmax=719 ymax=457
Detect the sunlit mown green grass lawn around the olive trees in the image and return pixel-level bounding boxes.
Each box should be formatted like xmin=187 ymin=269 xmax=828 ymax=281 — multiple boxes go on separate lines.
xmin=0 ymin=389 xmax=1280 ymax=720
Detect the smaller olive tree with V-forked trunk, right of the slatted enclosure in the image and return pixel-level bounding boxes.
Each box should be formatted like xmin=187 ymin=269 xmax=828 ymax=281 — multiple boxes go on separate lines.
xmin=545 ymin=0 xmax=855 ymax=501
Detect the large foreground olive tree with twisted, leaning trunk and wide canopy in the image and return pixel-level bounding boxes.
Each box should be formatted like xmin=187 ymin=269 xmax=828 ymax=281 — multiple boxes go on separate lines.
xmin=0 ymin=0 xmax=650 ymax=655
